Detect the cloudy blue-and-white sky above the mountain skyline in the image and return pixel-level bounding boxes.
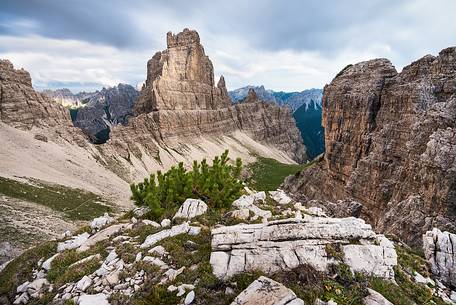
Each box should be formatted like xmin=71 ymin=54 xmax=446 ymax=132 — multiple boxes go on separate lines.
xmin=0 ymin=0 xmax=456 ymax=93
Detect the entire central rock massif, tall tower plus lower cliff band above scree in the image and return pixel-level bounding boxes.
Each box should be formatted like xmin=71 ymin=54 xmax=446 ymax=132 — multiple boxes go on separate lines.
xmin=110 ymin=29 xmax=306 ymax=162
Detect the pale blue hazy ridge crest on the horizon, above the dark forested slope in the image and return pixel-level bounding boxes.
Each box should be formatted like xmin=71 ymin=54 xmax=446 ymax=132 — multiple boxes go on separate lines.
xmin=228 ymin=86 xmax=323 ymax=112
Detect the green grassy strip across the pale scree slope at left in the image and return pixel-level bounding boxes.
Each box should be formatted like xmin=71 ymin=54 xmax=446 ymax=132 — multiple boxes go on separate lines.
xmin=0 ymin=177 xmax=112 ymax=220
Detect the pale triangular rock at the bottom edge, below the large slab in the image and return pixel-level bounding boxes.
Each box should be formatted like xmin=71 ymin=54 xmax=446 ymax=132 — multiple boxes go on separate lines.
xmin=231 ymin=276 xmax=304 ymax=305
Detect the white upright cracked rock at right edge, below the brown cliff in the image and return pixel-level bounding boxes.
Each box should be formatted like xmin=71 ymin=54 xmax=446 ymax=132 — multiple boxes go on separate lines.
xmin=423 ymin=228 xmax=456 ymax=287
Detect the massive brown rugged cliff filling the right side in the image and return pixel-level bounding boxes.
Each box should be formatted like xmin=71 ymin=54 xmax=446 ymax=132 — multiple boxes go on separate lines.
xmin=285 ymin=48 xmax=456 ymax=245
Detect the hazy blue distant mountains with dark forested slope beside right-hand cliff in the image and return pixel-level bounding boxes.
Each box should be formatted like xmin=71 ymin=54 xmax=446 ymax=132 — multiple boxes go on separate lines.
xmin=228 ymin=86 xmax=325 ymax=159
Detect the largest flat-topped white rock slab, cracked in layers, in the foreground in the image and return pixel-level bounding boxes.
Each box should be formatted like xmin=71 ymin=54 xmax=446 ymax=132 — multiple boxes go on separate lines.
xmin=210 ymin=215 xmax=397 ymax=279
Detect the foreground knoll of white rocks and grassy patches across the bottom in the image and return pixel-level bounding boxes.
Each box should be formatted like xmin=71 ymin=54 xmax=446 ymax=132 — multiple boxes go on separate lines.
xmin=0 ymin=188 xmax=456 ymax=305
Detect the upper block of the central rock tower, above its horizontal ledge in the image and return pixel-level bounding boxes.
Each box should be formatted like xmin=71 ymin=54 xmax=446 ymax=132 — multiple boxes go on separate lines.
xmin=135 ymin=29 xmax=231 ymax=114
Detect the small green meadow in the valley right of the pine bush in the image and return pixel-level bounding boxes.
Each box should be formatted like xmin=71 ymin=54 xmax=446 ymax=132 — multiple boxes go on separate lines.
xmin=248 ymin=157 xmax=309 ymax=191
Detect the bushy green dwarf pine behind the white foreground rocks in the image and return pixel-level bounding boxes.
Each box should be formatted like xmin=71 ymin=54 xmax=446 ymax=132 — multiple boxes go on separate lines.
xmin=130 ymin=150 xmax=242 ymax=219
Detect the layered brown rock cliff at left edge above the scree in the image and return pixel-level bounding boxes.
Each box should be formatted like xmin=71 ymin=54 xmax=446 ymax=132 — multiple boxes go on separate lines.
xmin=0 ymin=60 xmax=72 ymax=130
